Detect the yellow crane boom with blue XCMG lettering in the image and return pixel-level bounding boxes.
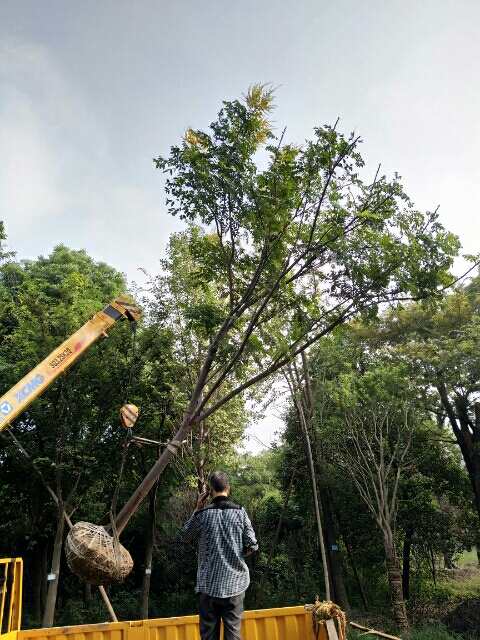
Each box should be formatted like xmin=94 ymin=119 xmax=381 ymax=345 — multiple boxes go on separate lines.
xmin=0 ymin=296 xmax=141 ymax=431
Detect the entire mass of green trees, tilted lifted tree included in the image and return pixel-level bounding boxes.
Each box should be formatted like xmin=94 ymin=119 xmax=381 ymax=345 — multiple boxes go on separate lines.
xmin=0 ymin=86 xmax=480 ymax=640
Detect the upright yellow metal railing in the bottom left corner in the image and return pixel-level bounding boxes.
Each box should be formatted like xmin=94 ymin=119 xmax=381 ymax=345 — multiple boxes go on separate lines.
xmin=0 ymin=558 xmax=23 ymax=640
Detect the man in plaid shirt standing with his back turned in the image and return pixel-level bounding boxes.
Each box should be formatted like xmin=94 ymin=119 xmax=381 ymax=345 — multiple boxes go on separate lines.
xmin=181 ymin=471 xmax=258 ymax=640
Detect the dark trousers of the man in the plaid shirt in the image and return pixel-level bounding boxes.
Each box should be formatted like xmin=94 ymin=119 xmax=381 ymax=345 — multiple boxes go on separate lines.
xmin=197 ymin=592 xmax=245 ymax=640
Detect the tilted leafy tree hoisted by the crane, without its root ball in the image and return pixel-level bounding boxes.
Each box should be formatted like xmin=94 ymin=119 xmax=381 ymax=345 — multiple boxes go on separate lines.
xmin=113 ymin=85 xmax=459 ymax=530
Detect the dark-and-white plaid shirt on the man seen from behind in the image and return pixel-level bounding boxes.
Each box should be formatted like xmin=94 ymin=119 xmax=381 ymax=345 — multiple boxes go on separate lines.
xmin=181 ymin=496 xmax=258 ymax=598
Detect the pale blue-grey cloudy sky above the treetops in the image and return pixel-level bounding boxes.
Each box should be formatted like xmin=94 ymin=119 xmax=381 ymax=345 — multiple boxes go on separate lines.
xmin=0 ymin=0 xmax=480 ymax=451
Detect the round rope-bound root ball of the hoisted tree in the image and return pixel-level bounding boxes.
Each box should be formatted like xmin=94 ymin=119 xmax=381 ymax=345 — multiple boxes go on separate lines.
xmin=65 ymin=522 xmax=133 ymax=585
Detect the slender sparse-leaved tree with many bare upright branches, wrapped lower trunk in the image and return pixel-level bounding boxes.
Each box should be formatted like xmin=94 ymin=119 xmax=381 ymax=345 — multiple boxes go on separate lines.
xmin=335 ymin=363 xmax=425 ymax=628
